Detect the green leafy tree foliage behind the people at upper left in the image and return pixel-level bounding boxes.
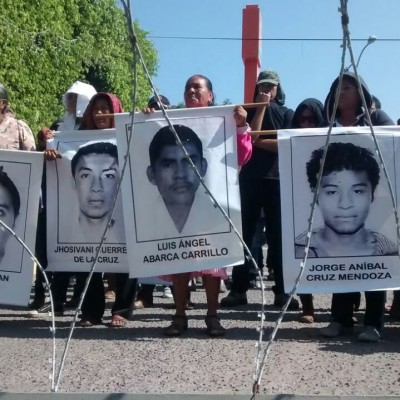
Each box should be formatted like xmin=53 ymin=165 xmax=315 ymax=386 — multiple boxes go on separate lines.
xmin=0 ymin=0 xmax=158 ymax=131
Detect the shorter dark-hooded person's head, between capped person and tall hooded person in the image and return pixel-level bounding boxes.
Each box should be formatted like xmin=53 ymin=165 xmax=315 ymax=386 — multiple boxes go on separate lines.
xmin=291 ymin=98 xmax=325 ymax=129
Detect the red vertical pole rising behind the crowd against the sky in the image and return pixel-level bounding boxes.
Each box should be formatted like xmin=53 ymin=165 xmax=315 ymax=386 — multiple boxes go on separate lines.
xmin=242 ymin=5 xmax=262 ymax=103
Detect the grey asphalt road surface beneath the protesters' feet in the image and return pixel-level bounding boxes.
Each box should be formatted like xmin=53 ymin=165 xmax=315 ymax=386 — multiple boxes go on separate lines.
xmin=0 ymin=282 xmax=400 ymax=400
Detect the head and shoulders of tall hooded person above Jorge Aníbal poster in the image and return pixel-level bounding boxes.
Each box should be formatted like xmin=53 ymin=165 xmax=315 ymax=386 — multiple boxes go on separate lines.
xmin=324 ymin=71 xmax=395 ymax=126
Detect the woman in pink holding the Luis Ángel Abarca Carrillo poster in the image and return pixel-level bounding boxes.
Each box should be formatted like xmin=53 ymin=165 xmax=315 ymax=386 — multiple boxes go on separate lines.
xmin=162 ymin=75 xmax=252 ymax=337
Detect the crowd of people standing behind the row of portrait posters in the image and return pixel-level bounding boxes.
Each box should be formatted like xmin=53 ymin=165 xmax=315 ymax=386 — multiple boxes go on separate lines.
xmin=0 ymin=70 xmax=400 ymax=342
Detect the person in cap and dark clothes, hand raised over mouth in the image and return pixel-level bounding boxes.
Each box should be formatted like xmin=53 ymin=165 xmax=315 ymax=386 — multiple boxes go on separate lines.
xmin=221 ymin=70 xmax=298 ymax=309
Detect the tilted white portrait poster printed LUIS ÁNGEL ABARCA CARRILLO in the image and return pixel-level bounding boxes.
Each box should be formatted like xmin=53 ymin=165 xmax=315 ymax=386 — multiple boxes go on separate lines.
xmin=116 ymin=107 xmax=243 ymax=277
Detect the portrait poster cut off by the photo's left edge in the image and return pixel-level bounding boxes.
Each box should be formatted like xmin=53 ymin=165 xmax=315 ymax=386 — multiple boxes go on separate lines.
xmin=0 ymin=150 xmax=43 ymax=306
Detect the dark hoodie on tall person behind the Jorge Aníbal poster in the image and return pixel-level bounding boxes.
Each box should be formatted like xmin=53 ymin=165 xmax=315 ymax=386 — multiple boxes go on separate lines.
xmin=324 ymin=71 xmax=395 ymax=126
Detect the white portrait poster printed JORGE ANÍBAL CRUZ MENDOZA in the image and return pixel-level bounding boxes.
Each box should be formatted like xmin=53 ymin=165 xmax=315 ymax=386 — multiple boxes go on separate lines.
xmin=278 ymin=127 xmax=400 ymax=293
